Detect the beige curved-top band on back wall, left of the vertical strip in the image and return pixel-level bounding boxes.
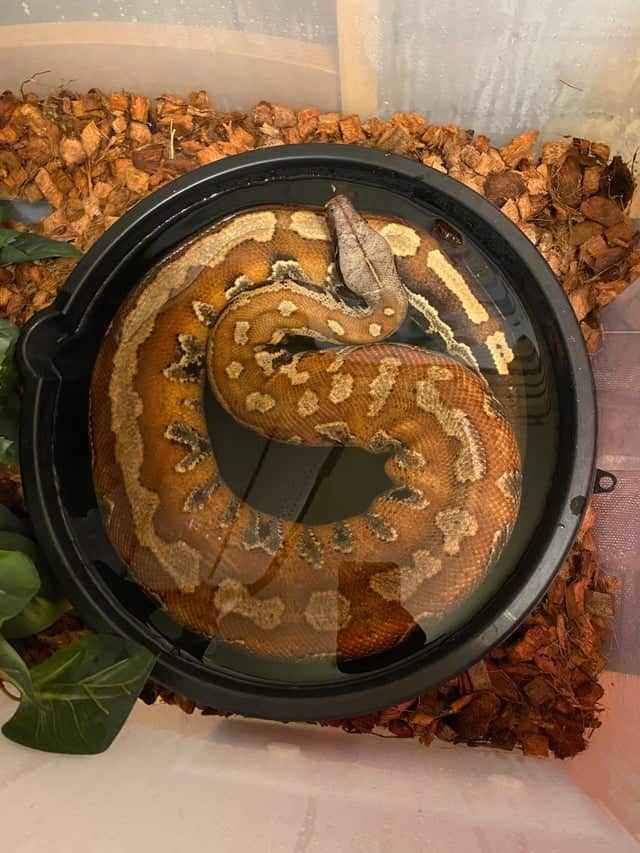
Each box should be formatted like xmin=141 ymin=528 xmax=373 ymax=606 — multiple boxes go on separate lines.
xmin=0 ymin=22 xmax=338 ymax=110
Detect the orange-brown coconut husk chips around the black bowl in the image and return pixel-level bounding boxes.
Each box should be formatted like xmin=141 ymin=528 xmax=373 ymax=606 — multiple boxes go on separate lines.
xmin=0 ymin=90 xmax=640 ymax=758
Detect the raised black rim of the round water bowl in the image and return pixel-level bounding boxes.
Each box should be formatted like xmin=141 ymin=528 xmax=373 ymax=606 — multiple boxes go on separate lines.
xmin=18 ymin=143 xmax=597 ymax=721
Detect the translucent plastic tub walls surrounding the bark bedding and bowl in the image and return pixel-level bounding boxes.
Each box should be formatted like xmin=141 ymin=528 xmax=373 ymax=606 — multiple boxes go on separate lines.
xmin=0 ymin=0 xmax=640 ymax=853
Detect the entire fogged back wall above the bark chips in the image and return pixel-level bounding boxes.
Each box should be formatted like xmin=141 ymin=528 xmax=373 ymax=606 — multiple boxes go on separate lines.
xmin=0 ymin=0 xmax=640 ymax=158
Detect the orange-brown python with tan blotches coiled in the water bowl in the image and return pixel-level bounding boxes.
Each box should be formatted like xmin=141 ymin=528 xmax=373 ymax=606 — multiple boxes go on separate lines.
xmin=91 ymin=196 xmax=521 ymax=659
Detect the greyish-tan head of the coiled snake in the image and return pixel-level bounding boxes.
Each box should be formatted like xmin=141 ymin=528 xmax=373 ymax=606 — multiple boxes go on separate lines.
xmin=325 ymin=195 xmax=406 ymax=306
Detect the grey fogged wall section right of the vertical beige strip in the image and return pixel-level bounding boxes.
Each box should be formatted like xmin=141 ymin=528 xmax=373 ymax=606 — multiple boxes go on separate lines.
xmin=377 ymin=0 xmax=640 ymax=156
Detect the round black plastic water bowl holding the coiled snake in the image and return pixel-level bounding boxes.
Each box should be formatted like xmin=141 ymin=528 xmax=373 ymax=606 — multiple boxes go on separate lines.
xmin=20 ymin=145 xmax=596 ymax=720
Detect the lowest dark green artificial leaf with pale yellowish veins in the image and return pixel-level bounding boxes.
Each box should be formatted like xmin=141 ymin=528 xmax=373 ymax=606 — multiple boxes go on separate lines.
xmin=2 ymin=634 xmax=155 ymax=755
